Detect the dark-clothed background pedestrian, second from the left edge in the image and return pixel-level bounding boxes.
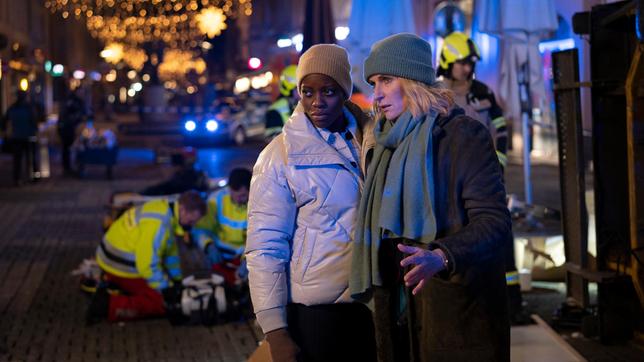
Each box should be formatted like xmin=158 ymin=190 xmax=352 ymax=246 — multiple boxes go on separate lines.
xmin=57 ymin=90 xmax=87 ymax=176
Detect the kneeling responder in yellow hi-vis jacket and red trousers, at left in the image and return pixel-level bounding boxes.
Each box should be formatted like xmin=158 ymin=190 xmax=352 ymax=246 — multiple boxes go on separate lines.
xmin=87 ymin=191 xmax=206 ymax=324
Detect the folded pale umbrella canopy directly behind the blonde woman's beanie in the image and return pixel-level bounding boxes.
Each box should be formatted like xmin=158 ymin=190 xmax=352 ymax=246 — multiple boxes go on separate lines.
xmin=343 ymin=0 xmax=415 ymax=94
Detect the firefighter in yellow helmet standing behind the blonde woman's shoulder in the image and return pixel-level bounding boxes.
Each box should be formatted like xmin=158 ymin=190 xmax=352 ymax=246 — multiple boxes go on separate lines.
xmin=437 ymin=32 xmax=523 ymax=323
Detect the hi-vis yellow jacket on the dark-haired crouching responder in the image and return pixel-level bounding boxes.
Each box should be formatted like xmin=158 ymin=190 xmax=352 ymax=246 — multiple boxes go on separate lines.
xmin=193 ymin=188 xmax=248 ymax=260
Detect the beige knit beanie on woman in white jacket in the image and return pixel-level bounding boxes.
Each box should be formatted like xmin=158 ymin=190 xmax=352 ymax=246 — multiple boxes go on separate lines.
xmin=296 ymin=44 xmax=353 ymax=99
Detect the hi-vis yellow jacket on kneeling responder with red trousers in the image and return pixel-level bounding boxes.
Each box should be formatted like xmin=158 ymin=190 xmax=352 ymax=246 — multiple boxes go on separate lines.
xmin=96 ymin=200 xmax=183 ymax=290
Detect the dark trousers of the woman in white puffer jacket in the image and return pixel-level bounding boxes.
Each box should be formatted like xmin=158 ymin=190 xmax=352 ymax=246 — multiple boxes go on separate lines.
xmin=286 ymin=303 xmax=376 ymax=362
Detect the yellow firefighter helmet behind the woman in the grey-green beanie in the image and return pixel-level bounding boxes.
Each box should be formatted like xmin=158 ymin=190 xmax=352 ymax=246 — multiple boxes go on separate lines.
xmin=438 ymin=32 xmax=481 ymax=78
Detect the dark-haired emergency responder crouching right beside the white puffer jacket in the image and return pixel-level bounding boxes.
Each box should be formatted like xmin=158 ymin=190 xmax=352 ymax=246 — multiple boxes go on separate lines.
xmin=192 ymin=168 xmax=251 ymax=286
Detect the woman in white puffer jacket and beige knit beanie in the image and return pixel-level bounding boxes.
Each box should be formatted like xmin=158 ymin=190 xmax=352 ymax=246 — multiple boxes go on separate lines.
xmin=246 ymin=44 xmax=375 ymax=361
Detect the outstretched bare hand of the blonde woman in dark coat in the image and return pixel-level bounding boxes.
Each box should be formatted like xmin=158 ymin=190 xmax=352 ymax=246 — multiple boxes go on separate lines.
xmin=398 ymin=244 xmax=446 ymax=295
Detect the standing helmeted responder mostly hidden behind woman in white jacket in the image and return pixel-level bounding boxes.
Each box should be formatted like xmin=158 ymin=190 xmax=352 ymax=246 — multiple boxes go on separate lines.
xmin=264 ymin=65 xmax=299 ymax=142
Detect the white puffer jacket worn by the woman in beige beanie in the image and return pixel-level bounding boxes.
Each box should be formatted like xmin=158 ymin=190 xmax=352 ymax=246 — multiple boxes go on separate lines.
xmin=246 ymin=102 xmax=373 ymax=333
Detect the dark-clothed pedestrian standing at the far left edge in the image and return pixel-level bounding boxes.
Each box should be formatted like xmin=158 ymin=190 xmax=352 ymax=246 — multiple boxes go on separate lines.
xmin=2 ymin=91 xmax=38 ymax=186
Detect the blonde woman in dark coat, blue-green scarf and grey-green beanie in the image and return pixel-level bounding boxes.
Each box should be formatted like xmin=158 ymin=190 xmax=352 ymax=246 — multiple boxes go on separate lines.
xmin=350 ymin=33 xmax=511 ymax=361
